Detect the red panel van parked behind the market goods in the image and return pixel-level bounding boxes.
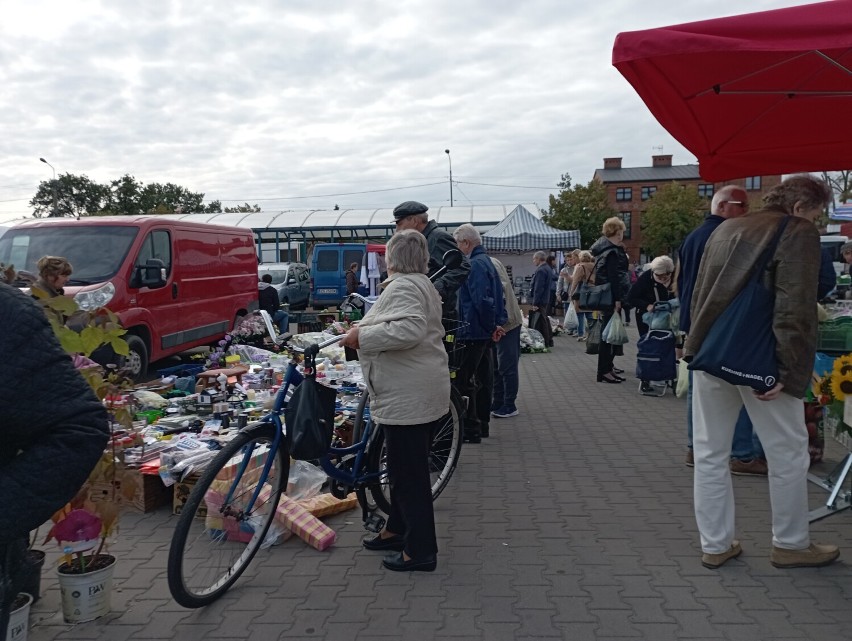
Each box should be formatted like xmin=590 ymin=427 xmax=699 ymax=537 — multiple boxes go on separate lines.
xmin=0 ymin=216 xmax=258 ymax=378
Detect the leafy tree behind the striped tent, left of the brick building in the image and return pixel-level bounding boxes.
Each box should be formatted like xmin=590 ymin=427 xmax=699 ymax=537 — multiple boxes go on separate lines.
xmin=542 ymin=174 xmax=618 ymax=248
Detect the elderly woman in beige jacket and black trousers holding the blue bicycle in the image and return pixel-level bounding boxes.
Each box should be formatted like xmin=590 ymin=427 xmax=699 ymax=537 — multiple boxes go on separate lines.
xmin=341 ymin=230 xmax=450 ymax=572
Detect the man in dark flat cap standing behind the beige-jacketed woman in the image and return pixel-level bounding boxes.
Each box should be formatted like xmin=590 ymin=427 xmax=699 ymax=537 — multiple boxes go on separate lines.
xmin=393 ymin=200 xmax=470 ymax=331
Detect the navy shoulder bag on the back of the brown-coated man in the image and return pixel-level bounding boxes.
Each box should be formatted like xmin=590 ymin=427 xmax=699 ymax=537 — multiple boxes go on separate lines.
xmin=689 ymin=216 xmax=790 ymax=392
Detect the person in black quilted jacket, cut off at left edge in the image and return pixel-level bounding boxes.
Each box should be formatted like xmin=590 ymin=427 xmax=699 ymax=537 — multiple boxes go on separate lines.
xmin=0 ymin=277 xmax=109 ymax=633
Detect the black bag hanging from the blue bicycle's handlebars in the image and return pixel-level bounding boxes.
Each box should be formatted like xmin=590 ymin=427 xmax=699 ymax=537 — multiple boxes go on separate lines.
xmin=284 ymin=376 xmax=337 ymax=461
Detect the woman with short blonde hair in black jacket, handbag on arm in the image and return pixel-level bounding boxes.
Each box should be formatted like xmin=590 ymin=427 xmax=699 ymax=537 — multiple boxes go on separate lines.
xmin=591 ymin=216 xmax=628 ymax=383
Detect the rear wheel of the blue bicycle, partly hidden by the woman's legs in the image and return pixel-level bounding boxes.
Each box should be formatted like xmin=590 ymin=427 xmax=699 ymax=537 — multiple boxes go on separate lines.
xmin=362 ymin=388 xmax=464 ymax=514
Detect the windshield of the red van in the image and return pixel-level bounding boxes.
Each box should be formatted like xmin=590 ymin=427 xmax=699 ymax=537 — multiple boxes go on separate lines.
xmin=0 ymin=225 xmax=139 ymax=285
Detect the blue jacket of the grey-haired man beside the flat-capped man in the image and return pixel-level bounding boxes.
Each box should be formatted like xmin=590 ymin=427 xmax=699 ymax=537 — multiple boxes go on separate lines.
xmin=458 ymin=246 xmax=506 ymax=341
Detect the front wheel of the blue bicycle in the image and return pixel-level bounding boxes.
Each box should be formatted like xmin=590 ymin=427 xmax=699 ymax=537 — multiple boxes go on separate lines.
xmin=168 ymin=423 xmax=290 ymax=608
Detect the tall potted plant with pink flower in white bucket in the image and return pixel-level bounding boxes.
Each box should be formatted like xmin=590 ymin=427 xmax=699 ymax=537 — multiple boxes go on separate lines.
xmin=35 ymin=292 xmax=138 ymax=623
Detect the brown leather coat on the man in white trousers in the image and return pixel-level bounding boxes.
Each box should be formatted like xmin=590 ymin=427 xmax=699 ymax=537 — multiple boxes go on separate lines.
xmin=684 ymin=209 xmax=820 ymax=398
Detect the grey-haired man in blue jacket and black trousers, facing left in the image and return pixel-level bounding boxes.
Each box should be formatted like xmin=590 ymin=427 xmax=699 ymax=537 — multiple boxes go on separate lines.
xmin=453 ymin=223 xmax=508 ymax=443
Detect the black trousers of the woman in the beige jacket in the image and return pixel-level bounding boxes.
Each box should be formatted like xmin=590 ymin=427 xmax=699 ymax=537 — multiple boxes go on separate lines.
xmin=382 ymin=421 xmax=438 ymax=559
